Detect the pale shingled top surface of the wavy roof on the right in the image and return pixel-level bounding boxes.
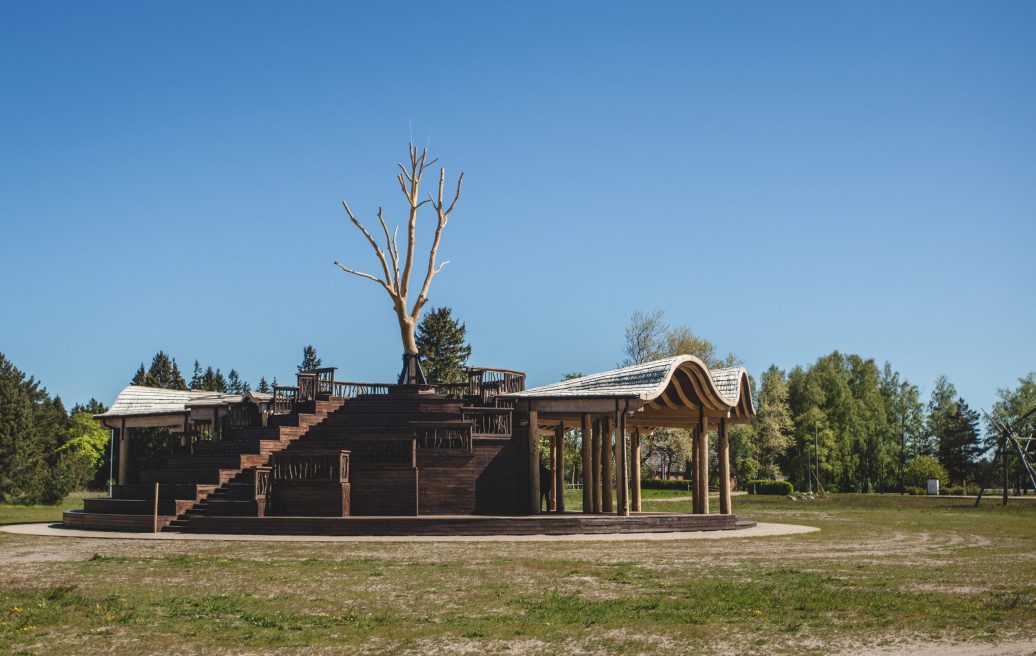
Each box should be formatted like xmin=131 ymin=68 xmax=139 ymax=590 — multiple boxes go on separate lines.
xmin=509 ymin=355 xmax=748 ymax=406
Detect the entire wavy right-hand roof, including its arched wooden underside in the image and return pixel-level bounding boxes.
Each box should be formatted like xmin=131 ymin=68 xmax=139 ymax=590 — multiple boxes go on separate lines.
xmin=509 ymin=355 xmax=755 ymax=419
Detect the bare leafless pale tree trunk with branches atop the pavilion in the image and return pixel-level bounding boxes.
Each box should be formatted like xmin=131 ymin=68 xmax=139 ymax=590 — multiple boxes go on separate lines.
xmin=335 ymin=143 xmax=464 ymax=382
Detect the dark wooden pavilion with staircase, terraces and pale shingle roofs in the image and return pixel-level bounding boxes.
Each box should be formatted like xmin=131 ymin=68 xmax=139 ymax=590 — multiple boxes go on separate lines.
xmin=64 ymin=355 xmax=754 ymax=535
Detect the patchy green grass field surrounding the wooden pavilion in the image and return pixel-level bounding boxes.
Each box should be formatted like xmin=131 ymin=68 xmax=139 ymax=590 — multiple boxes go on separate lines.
xmin=0 ymin=491 xmax=1036 ymax=654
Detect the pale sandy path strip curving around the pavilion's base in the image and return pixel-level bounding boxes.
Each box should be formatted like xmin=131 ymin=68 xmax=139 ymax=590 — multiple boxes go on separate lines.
xmin=0 ymin=523 xmax=819 ymax=542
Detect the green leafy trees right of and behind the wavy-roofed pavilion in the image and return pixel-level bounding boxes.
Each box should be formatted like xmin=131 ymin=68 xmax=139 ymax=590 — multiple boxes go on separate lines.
xmin=621 ymin=310 xmax=1036 ymax=492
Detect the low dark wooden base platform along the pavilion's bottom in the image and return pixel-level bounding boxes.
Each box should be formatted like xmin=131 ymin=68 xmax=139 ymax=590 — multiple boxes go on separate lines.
xmin=63 ymin=511 xmax=755 ymax=536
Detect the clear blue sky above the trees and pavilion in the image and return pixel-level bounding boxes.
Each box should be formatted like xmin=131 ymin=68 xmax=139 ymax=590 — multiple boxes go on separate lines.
xmin=0 ymin=1 xmax=1036 ymax=406
